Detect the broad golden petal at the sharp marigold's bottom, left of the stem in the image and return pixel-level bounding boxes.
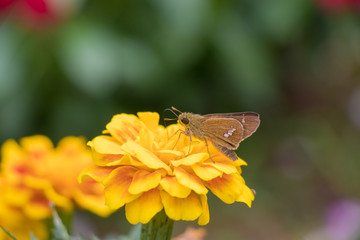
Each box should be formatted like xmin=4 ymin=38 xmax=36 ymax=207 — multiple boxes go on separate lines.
xmin=125 ymin=189 xmax=163 ymax=224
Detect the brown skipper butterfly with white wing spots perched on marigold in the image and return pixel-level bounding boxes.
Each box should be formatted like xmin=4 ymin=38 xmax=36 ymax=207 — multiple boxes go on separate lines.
xmin=165 ymin=107 xmax=260 ymax=160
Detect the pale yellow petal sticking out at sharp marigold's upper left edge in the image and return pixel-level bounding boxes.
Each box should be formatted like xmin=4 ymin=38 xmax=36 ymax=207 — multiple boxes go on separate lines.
xmin=88 ymin=136 xmax=125 ymax=155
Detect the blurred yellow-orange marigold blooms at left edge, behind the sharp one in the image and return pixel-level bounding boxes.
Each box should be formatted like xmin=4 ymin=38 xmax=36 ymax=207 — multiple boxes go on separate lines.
xmin=0 ymin=136 xmax=112 ymax=239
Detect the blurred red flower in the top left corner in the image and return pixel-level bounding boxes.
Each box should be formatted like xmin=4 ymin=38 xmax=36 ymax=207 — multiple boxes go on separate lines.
xmin=0 ymin=0 xmax=76 ymax=29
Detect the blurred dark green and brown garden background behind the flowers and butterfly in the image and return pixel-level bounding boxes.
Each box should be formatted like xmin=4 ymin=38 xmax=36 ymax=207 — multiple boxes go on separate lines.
xmin=0 ymin=0 xmax=360 ymax=240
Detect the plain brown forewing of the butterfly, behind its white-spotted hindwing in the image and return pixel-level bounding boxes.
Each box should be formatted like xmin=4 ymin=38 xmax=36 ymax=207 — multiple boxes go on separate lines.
xmin=203 ymin=112 xmax=260 ymax=141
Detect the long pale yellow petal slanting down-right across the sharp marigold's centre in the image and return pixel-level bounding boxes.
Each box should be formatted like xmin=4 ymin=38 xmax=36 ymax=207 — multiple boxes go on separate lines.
xmin=122 ymin=141 xmax=171 ymax=173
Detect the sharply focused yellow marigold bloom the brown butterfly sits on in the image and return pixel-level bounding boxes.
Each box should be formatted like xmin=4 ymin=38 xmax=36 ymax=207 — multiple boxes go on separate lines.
xmin=80 ymin=112 xmax=254 ymax=225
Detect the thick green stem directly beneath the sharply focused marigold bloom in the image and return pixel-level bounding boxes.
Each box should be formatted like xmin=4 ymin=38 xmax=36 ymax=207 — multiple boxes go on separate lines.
xmin=140 ymin=210 xmax=174 ymax=240
